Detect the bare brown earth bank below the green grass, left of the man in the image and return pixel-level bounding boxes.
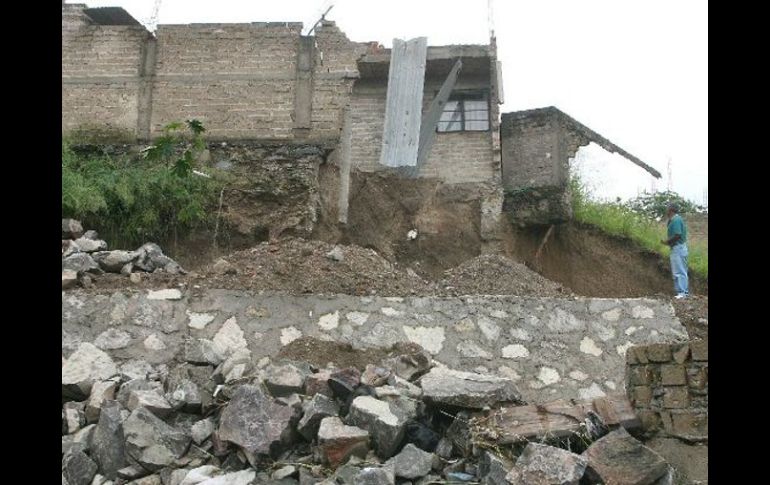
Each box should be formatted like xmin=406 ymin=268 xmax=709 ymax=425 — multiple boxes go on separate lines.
xmin=506 ymin=223 xmax=708 ymax=298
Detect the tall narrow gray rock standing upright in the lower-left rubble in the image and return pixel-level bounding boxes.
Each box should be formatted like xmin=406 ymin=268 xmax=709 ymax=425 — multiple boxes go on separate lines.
xmin=91 ymin=401 xmax=126 ymax=480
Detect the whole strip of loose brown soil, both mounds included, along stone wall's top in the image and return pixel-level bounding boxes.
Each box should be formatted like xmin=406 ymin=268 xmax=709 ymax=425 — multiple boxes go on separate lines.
xmin=84 ymin=238 xmax=569 ymax=296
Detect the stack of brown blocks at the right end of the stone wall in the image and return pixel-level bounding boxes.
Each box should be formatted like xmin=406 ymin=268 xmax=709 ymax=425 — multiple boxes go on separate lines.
xmin=626 ymin=340 xmax=708 ymax=441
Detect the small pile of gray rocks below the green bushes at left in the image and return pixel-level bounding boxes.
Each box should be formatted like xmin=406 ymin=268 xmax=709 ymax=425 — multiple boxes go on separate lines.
xmin=61 ymin=219 xmax=186 ymax=290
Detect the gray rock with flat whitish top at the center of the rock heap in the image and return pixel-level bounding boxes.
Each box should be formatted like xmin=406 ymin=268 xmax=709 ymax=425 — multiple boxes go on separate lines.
xmin=347 ymin=396 xmax=413 ymax=458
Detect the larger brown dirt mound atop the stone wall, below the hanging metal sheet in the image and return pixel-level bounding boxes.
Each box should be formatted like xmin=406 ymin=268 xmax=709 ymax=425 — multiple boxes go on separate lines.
xmin=191 ymin=239 xmax=431 ymax=295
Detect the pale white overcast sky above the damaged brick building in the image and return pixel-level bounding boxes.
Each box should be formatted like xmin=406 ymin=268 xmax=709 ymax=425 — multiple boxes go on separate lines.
xmin=67 ymin=0 xmax=708 ymax=203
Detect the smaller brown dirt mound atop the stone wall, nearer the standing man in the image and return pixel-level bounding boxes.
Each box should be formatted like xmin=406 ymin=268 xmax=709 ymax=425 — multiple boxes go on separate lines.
xmin=439 ymin=254 xmax=570 ymax=296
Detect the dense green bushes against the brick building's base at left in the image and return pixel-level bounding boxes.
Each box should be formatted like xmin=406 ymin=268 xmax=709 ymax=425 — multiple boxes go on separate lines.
xmin=62 ymin=120 xmax=222 ymax=246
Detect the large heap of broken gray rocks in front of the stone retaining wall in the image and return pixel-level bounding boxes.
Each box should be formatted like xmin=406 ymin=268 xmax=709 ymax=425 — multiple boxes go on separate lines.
xmin=62 ymin=340 xmax=672 ymax=485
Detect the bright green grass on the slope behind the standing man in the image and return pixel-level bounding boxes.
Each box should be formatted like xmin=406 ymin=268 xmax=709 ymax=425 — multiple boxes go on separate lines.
xmin=570 ymin=177 xmax=708 ymax=278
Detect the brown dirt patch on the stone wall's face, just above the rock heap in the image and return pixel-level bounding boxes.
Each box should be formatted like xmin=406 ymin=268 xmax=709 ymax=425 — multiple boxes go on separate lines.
xmin=277 ymin=337 xmax=424 ymax=370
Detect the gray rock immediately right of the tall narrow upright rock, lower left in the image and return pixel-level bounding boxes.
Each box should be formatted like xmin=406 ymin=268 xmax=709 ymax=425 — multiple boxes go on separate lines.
xmin=123 ymin=408 xmax=190 ymax=471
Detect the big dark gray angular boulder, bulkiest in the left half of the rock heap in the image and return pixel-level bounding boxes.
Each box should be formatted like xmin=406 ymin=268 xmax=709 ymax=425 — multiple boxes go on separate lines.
xmin=218 ymin=385 xmax=294 ymax=466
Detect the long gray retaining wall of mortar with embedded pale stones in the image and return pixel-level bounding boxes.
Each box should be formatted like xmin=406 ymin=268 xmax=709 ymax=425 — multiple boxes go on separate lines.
xmin=62 ymin=290 xmax=686 ymax=400
